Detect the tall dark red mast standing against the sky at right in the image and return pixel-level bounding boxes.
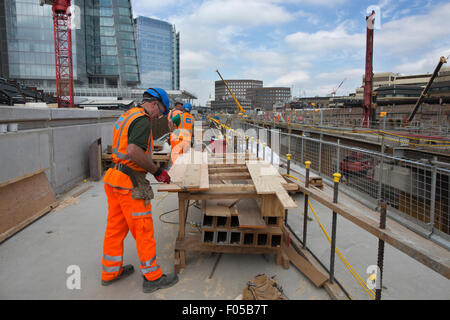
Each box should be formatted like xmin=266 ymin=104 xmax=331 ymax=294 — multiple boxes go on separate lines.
xmin=362 ymin=11 xmax=375 ymax=127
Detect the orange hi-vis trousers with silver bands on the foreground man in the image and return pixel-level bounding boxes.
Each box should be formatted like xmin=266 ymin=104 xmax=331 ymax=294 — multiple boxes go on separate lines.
xmin=102 ymin=184 xmax=162 ymax=281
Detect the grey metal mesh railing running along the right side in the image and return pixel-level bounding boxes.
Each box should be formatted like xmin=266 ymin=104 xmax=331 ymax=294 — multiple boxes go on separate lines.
xmin=233 ymin=121 xmax=450 ymax=241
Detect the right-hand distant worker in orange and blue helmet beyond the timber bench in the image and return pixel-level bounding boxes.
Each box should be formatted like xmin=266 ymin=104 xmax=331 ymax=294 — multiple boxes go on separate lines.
xmin=170 ymin=102 xmax=194 ymax=165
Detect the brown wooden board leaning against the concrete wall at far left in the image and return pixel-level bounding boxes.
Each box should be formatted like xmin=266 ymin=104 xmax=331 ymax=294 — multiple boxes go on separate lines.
xmin=0 ymin=170 xmax=57 ymax=242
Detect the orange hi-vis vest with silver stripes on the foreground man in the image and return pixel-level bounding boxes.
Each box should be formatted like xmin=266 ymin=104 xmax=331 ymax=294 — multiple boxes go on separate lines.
xmin=103 ymin=107 xmax=153 ymax=190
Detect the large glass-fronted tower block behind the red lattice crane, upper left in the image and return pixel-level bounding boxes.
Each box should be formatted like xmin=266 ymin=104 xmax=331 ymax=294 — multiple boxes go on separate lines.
xmin=0 ymin=0 xmax=140 ymax=88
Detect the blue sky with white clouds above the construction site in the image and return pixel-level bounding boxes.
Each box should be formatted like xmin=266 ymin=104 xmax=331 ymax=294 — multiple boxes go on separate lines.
xmin=132 ymin=0 xmax=450 ymax=105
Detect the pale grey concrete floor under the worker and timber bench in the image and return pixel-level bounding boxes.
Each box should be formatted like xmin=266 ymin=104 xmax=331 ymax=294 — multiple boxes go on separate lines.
xmin=0 ymin=172 xmax=450 ymax=300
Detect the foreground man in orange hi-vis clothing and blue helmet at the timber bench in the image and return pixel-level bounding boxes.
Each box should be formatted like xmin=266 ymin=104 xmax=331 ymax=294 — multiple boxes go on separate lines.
xmin=102 ymin=88 xmax=178 ymax=292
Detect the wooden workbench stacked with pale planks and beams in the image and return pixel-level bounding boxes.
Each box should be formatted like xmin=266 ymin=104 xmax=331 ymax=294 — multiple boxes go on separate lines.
xmin=158 ymin=151 xmax=343 ymax=299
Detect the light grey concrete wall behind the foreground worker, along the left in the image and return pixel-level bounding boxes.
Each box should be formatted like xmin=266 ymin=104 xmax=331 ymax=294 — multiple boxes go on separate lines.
xmin=0 ymin=106 xmax=122 ymax=194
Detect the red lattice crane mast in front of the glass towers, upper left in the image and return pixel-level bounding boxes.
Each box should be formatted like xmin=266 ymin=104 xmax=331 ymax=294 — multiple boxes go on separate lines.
xmin=40 ymin=0 xmax=74 ymax=108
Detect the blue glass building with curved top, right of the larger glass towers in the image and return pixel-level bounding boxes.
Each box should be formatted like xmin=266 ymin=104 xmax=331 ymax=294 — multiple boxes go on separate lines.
xmin=135 ymin=17 xmax=180 ymax=90
